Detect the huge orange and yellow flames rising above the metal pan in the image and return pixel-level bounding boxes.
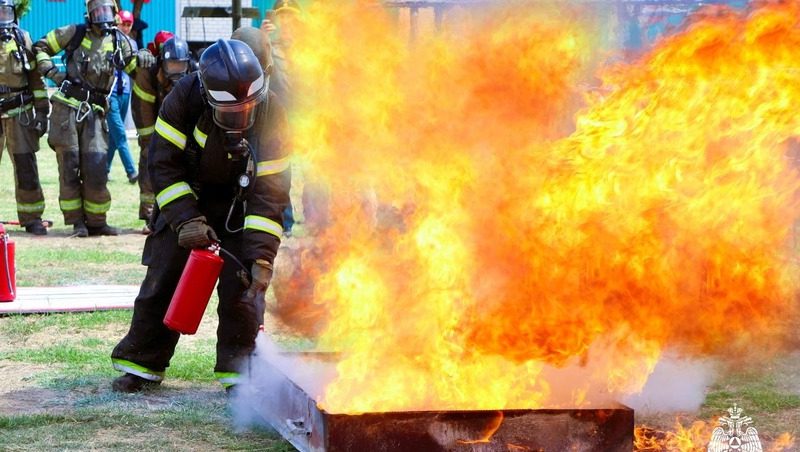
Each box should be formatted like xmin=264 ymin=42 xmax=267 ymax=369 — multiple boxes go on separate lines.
xmin=278 ymin=1 xmax=800 ymax=412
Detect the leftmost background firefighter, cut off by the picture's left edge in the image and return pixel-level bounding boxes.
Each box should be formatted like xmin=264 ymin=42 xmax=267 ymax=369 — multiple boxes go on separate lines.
xmin=0 ymin=0 xmax=50 ymax=235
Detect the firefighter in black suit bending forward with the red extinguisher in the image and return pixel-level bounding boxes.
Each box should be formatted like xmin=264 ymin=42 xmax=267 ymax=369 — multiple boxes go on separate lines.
xmin=111 ymin=39 xmax=289 ymax=392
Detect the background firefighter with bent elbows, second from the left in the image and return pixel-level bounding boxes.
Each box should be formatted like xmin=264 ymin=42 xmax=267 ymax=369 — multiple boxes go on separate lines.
xmin=34 ymin=0 xmax=155 ymax=237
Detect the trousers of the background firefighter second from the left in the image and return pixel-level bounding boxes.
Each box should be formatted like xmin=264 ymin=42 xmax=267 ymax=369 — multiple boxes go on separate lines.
xmin=47 ymin=102 xmax=111 ymax=226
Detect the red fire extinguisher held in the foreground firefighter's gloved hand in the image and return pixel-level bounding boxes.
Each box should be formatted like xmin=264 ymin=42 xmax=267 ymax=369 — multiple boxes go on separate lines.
xmin=164 ymin=244 xmax=223 ymax=334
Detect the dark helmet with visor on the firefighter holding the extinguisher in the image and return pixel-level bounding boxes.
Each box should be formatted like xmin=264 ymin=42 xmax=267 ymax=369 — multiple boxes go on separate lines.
xmin=200 ymin=39 xmax=269 ymax=131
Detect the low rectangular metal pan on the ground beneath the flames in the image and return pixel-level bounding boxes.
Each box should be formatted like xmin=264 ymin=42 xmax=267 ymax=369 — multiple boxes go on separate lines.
xmin=241 ymin=354 xmax=633 ymax=452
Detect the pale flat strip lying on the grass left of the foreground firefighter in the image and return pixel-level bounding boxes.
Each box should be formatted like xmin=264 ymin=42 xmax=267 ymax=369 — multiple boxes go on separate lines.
xmin=0 ymin=285 xmax=139 ymax=315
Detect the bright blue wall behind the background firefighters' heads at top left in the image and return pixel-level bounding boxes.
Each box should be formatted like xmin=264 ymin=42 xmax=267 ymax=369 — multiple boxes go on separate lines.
xmin=20 ymin=0 xmax=178 ymax=46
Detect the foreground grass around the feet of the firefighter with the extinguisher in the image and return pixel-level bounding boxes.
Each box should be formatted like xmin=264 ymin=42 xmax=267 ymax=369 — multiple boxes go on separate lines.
xmin=0 ymin=297 xmax=293 ymax=452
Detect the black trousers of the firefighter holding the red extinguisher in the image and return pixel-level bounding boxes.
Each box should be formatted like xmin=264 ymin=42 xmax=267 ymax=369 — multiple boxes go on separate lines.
xmin=111 ymin=214 xmax=264 ymax=373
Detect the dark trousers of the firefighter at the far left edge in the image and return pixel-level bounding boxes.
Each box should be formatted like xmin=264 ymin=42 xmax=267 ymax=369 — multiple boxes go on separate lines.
xmin=0 ymin=117 xmax=44 ymax=225
